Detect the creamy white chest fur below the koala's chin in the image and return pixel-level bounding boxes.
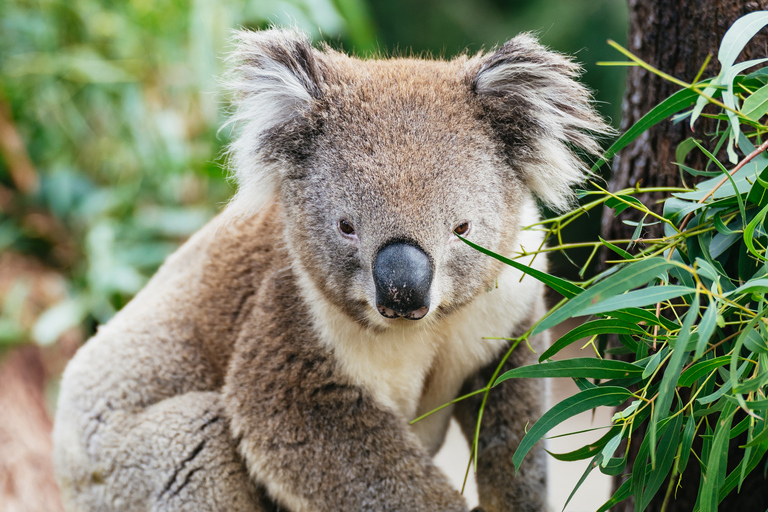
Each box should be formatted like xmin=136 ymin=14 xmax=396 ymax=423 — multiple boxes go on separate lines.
xmin=299 ymin=248 xmax=542 ymax=454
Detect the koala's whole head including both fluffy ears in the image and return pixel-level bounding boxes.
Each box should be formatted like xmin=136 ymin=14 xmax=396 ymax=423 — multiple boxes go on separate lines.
xmin=224 ymin=30 xmax=607 ymax=327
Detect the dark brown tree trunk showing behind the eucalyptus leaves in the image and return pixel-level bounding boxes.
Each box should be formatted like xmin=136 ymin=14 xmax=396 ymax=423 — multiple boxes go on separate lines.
xmin=602 ymin=0 xmax=768 ymax=512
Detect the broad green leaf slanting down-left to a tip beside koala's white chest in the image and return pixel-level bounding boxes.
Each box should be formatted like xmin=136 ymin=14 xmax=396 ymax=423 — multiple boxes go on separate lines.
xmin=533 ymin=258 xmax=674 ymax=334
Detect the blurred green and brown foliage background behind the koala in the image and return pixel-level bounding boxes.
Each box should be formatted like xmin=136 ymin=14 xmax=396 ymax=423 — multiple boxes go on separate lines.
xmin=0 ymin=0 xmax=627 ymax=510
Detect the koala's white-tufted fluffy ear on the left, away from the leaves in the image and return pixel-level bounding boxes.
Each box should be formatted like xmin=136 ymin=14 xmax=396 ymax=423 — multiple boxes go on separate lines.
xmin=225 ymin=29 xmax=327 ymax=214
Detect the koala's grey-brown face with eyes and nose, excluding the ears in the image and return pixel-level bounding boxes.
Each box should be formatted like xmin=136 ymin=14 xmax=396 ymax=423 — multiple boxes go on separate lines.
xmin=282 ymin=59 xmax=527 ymax=325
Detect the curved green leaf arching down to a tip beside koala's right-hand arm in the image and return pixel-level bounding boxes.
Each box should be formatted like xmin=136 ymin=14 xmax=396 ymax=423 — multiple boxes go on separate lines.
xmin=512 ymin=386 xmax=632 ymax=473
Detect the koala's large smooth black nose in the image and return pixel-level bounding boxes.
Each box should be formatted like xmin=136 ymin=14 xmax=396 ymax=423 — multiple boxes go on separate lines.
xmin=373 ymin=242 xmax=432 ymax=320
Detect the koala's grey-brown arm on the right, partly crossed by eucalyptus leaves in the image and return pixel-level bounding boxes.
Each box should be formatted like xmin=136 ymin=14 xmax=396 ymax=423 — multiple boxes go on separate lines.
xmin=454 ymin=333 xmax=548 ymax=512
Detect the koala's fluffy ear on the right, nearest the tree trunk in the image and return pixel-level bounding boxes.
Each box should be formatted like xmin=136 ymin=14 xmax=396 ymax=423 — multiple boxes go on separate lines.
xmin=470 ymin=34 xmax=612 ymax=210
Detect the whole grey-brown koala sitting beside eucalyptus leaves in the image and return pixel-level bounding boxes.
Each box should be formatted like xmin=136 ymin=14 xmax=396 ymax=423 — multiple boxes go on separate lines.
xmin=53 ymin=28 xmax=607 ymax=512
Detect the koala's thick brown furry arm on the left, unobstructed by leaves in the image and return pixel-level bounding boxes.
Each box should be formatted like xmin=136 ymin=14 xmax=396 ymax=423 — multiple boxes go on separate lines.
xmin=224 ymin=279 xmax=467 ymax=512
